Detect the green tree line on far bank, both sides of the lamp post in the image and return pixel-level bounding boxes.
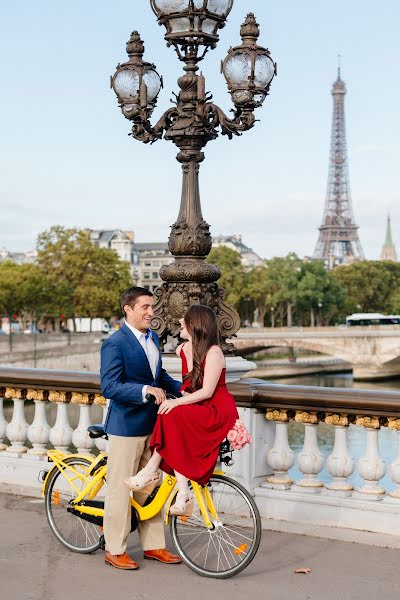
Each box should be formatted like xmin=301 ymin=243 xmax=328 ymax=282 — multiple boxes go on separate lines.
xmin=0 ymin=226 xmax=400 ymax=326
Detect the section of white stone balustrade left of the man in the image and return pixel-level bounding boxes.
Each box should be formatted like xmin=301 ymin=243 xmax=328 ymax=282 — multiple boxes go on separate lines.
xmin=0 ymin=367 xmax=107 ymax=495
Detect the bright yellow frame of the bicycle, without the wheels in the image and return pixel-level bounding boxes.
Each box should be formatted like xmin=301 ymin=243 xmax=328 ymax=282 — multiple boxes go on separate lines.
xmin=42 ymin=450 xmax=227 ymax=529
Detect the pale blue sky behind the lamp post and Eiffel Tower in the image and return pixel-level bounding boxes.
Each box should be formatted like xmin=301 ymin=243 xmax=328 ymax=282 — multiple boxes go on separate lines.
xmin=0 ymin=0 xmax=400 ymax=259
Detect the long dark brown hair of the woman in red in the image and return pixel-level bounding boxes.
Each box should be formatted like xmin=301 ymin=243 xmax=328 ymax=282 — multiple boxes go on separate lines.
xmin=183 ymin=304 xmax=220 ymax=392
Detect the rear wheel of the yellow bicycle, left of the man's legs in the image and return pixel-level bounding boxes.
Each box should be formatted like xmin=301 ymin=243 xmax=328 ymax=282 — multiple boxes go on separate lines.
xmin=45 ymin=456 xmax=104 ymax=554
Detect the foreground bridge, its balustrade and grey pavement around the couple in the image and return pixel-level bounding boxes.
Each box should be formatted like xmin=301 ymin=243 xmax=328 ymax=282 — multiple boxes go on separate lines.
xmin=0 ymin=368 xmax=400 ymax=600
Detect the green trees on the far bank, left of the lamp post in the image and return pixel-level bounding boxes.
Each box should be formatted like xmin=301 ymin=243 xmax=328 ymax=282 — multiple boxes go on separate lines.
xmin=0 ymin=227 xmax=132 ymax=321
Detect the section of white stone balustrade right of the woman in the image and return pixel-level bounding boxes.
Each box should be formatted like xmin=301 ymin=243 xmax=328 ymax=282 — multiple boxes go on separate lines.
xmin=225 ymin=380 xmax=400 ymax=534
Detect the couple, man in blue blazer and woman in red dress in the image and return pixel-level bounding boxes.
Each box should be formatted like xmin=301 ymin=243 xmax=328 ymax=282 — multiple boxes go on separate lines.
xmin=101 ymin=287 xmax=238 ymax=569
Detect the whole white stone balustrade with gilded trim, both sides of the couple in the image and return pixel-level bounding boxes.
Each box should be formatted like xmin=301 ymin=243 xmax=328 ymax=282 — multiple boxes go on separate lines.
xmin=0 ymin=368 xmax=400 ymax=534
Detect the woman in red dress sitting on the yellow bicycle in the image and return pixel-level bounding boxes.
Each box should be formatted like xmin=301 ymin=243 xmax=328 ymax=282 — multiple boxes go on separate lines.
xmin=126 ymin=304 xmax=238 ymax=516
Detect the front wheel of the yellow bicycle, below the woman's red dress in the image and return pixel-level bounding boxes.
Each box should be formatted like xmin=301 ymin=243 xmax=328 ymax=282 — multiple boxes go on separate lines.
xmin=170 ymin=475 xmax=261 ymax=579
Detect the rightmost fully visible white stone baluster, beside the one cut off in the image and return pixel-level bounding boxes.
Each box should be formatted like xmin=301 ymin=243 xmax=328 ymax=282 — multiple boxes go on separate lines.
xmin=354 ymin=416 xmax=386 ymax=500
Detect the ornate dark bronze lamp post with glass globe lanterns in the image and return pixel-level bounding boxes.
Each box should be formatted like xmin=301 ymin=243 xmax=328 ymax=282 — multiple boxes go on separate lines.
xmin=111 ymin=0 xmax=276 ymax=342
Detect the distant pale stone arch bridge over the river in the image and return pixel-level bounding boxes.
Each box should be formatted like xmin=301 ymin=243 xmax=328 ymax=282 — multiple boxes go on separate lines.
xmin=233 ymin=325 xmax=400 ymax=380
